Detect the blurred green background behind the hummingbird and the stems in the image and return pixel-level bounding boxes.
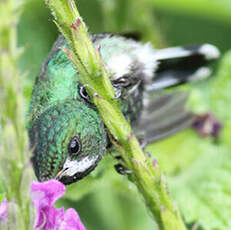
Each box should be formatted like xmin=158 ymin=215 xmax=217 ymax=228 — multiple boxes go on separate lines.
xmin=18 ymin=0 xmax=231 ymax=230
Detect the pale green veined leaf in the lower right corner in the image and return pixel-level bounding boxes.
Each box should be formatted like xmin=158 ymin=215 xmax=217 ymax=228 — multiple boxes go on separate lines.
xmin=169 ymin=144 xmax=231 ymax=229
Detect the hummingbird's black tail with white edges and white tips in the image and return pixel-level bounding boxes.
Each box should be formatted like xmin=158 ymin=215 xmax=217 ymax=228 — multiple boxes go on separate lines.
xmin=147 ymin=44 xmax=220 ymax=90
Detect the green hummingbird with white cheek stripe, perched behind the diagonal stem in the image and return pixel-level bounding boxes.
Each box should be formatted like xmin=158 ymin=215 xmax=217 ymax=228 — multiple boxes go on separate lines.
xmin=28 ymin=33 xmax=219 ymax=184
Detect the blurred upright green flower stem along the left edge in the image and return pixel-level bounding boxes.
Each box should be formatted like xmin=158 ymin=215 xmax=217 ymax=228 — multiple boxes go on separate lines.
xmin=0 ymin=0 xmax=33 ymax=229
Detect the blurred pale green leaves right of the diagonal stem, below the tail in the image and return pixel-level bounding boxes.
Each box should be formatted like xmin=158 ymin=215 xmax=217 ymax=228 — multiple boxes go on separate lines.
xmin=146 ymin=52 xmax=231 ymax=229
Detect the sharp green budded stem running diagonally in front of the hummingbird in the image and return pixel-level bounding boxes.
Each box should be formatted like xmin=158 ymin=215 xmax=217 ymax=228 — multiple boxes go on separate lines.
xmin=47 ymin=0 xmax=186 ymax=230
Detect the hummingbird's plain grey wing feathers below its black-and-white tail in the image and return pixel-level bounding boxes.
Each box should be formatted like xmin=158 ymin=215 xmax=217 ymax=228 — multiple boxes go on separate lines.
xmin=133 ymin=92 xmax=195 ymax=143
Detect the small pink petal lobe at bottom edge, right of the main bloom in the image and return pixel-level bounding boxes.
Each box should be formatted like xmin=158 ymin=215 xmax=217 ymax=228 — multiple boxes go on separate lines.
xmin=60 ymin=208 xmax=85 ymax=230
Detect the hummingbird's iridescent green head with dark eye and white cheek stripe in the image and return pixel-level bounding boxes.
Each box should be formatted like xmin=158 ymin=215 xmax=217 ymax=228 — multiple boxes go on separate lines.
xmin=29 ymin=100 xmax=107 ymax=184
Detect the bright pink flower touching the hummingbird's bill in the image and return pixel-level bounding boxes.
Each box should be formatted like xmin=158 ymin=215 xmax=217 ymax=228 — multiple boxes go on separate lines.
xmin=31 ymin=180 xmax=85 ymax=230
